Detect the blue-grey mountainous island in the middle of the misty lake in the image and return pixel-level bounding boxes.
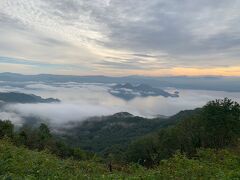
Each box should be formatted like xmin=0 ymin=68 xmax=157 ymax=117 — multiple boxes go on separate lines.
xmin=108 ymin=83 xmax=179 ymax=100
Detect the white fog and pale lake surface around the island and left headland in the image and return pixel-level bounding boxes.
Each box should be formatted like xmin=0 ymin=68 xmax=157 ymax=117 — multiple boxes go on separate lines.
xmin=0 ymin=82 xmax=240 ymax=124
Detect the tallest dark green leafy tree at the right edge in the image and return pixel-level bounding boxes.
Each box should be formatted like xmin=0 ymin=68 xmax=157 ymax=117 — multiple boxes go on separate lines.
xmin=201 ymin=98 xmax=240 ymax=148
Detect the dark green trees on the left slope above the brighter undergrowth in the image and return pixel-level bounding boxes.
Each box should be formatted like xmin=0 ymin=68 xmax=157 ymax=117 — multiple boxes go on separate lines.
xmin=0 ymin=120 xmax=96 ymax=160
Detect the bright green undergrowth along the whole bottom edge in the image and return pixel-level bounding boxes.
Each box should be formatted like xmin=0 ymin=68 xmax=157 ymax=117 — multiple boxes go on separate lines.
xmin=0 ymin=140 xmax=240 ymax=180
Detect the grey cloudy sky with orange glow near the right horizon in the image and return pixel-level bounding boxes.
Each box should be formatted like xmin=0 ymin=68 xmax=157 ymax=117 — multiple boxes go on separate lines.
xmin=0 ymin=0 xmax=240 ymax=76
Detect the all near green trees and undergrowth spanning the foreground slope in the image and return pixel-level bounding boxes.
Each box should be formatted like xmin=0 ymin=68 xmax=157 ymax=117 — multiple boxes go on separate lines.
xmin=0 ymin=98 xmax=240 ymax=179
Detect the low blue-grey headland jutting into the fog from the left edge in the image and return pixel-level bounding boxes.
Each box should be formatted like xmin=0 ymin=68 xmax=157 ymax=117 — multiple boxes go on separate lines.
xmin=0 ymin=92 xmax=60 ymax=103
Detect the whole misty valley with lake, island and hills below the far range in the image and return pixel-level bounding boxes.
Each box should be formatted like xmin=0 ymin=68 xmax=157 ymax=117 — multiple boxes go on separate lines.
xmin=0 ymin=74 xmax=240 ymax=156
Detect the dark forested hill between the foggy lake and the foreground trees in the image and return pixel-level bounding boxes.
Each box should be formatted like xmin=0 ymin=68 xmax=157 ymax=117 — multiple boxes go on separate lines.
xmin=58 ymin=110 xmax=198 ymax=154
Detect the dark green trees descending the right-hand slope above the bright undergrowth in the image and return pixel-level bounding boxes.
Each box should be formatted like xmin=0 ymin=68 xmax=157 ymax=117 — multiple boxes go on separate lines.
xmin=126 ymin=98 xmax=240 ymax=167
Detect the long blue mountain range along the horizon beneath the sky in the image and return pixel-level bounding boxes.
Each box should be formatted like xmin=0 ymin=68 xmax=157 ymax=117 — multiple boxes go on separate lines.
xmin=0 ymin=73 xmax=240 ymax=92
